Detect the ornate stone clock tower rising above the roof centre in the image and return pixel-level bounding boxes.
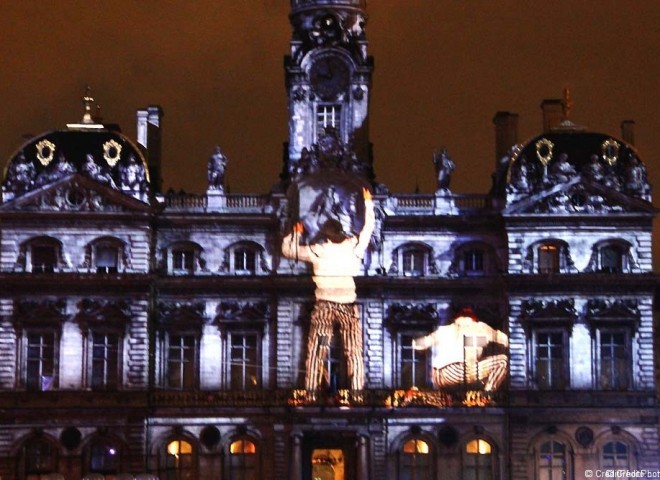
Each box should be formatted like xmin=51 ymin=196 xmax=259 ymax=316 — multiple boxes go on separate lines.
xmin=283 ymin=0 xmax=373 ymax=180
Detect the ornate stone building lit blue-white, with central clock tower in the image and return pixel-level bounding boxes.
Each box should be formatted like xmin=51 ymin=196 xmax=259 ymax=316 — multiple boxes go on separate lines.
xmin=0 ymin=0 xmax=660 ymax=480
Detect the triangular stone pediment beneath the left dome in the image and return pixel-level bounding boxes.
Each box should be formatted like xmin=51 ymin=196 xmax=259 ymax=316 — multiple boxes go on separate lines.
xmin=0 ymin=174 xmax=151 ymax=213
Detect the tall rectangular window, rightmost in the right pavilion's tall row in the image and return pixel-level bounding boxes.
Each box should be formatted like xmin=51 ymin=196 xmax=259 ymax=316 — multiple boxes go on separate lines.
xmin=599 ymin=331 xmax=630 ymax=390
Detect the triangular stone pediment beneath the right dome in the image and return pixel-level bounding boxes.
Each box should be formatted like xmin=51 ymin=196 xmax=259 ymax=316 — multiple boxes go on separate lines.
xmin=504 ymin=176 xmax=655 ymax=215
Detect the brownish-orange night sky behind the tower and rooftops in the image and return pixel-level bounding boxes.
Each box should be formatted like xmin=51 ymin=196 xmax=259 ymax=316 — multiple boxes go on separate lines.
xmin=0 ymin=0 xmax=660 ymax=197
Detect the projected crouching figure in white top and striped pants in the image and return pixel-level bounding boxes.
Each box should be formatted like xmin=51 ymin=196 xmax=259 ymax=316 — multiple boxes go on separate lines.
xmin=413 ymin=308 xmax=509 ymax=392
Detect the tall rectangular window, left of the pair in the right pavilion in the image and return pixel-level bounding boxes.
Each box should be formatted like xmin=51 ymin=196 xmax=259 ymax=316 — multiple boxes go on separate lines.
xmin=535 ymin=332 xmax=568 ymax=389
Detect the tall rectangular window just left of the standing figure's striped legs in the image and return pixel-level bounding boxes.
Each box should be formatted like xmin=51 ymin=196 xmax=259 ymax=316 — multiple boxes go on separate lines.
xmin=229 ymin=333 xmax=261 ymax=390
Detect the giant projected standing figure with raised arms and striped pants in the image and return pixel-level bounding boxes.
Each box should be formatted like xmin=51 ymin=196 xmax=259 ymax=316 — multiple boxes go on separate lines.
xmin=282 ymin=188 xmax=374 ymax=391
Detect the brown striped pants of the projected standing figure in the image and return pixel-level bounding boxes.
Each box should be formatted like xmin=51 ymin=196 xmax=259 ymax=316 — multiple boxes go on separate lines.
xmin=305 ymin=300 xmax=364 ymax=390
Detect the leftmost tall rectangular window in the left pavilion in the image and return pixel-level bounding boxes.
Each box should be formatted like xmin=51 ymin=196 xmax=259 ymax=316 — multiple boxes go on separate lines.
xmin=26 ymin=332 xmax=56 ymax=391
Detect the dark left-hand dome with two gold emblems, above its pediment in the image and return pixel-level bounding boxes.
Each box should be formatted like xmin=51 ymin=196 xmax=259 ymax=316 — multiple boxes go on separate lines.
xmin=2 ymin=124 xmax=149 ymax=200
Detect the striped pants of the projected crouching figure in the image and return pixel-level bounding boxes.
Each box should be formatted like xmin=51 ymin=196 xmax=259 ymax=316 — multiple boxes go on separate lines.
xmin=433 ymin=355 xmax=509 ymax=392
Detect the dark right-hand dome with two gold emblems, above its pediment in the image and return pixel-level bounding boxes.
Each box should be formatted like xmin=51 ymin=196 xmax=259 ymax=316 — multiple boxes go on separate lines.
xmin=505 ymin=121 xmax=651 ymax=200
